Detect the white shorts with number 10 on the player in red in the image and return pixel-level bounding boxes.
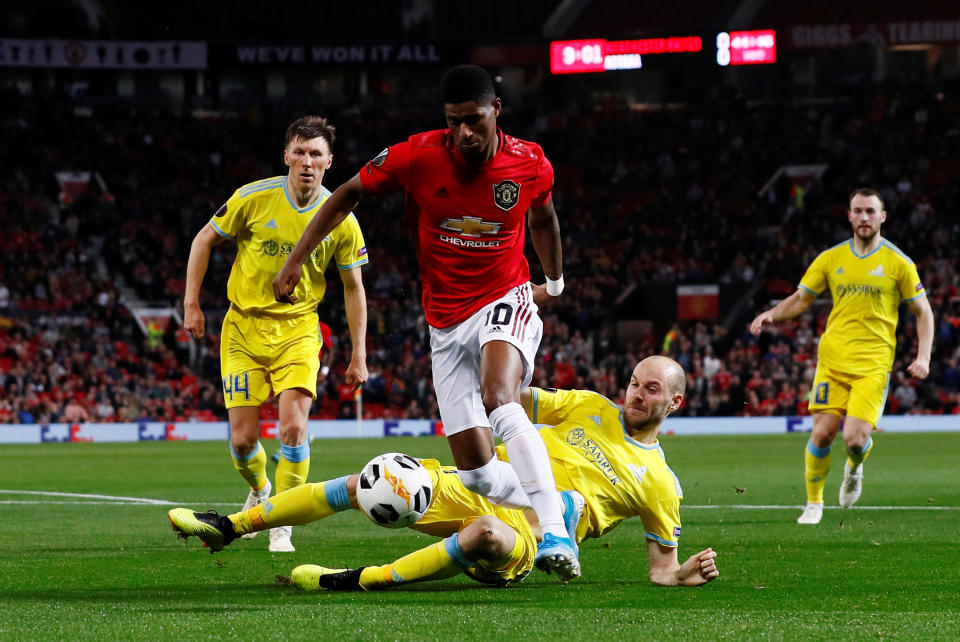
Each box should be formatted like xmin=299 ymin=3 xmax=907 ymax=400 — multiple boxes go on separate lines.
xmin=430 ymin=283 xmax=543 ymax=435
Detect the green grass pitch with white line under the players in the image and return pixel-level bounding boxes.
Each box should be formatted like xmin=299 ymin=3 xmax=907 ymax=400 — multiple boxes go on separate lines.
xmin=0 ymin=427 xmax=960 ymax=640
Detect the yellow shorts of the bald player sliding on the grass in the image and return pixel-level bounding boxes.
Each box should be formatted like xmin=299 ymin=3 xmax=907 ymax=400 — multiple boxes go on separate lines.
xmin=410 ymin=459 xmax=537 ymax=586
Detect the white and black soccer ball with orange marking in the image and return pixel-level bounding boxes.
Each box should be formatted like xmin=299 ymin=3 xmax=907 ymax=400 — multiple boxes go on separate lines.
xmin=357 ymin=453 xmax=433 ymax=528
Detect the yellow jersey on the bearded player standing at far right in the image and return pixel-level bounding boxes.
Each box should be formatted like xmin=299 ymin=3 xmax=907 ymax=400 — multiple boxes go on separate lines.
xmin=800 ymin=239 xmax=926 ymax=375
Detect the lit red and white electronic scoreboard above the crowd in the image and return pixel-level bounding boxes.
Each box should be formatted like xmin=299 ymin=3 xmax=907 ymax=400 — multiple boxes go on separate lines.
xmin=550 ymin=29 xmax=777 ymax=74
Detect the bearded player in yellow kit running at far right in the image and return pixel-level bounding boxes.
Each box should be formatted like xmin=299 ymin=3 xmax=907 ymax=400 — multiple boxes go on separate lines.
xmin=750 ymin=188 xmax=933 ymax=524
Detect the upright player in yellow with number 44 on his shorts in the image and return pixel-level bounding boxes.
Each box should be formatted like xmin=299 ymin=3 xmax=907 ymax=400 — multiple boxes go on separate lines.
xmin=183 ymin=116 xmax=369 ymax=552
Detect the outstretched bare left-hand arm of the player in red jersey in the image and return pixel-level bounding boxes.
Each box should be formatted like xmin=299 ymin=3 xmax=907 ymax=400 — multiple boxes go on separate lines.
xmin=273 ymin=174 xmax=366 ymax=303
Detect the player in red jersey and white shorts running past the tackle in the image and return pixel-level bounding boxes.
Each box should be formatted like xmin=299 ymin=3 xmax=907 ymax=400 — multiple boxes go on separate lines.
xmin=273 ymin=65 xmax=580 ymax=580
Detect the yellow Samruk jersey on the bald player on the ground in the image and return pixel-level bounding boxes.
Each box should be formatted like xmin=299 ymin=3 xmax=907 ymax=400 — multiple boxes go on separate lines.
xmin=506 ymin=388 xmax=683 ymax=546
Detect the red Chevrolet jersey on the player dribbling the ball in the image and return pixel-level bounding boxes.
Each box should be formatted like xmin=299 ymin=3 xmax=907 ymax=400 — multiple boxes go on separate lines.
xmin=360 ymin=129 xmax=553 ymax=328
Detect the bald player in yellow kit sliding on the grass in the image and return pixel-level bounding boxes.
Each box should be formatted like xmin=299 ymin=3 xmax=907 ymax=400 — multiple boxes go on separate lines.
xmin=168 ymin=356 xmax=719 ymax=590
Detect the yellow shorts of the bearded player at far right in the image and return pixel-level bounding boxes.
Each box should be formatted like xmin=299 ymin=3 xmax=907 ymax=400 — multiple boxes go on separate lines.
xmin=809 ymin=364 xmax=890 ymax=428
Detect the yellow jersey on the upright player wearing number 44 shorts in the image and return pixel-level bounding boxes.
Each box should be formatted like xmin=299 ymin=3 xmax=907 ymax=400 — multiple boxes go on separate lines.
xmin=210 ymin=176 xmax=369 ymax=318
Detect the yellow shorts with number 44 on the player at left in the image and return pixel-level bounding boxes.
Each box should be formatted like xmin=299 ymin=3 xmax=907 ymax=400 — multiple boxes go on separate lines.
xmin=220 ymin=306 xmax=321 ymax=408
